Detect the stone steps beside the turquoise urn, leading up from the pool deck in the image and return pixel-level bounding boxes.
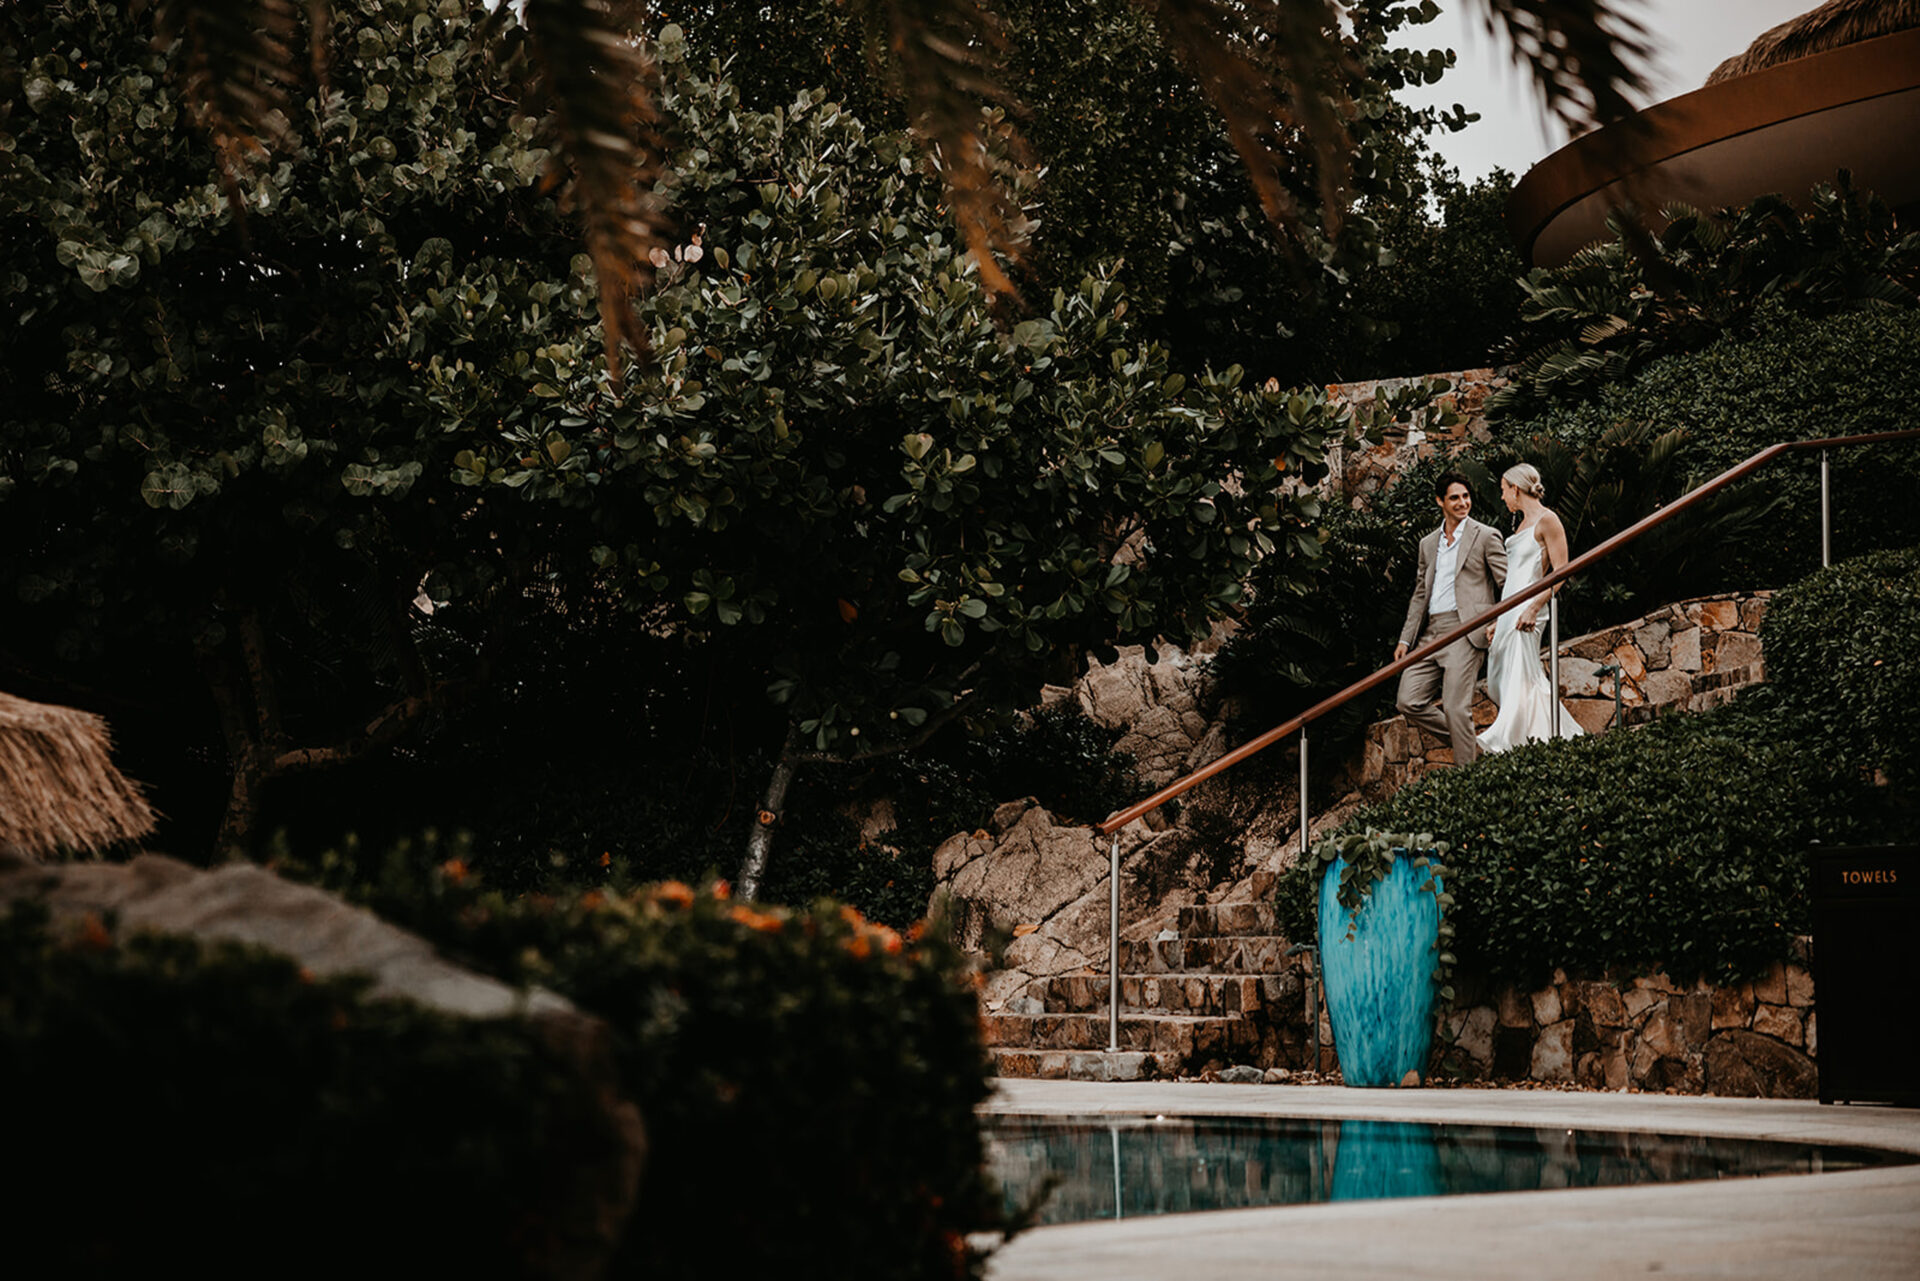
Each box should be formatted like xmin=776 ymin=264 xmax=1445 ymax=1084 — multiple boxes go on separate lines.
xmin=985 ymin=902 xmax=1311 ymax=1079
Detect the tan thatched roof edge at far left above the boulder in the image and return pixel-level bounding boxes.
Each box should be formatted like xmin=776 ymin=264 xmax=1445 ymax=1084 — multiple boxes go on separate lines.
xmin=0 ymin=693 xmax=154 ymax=858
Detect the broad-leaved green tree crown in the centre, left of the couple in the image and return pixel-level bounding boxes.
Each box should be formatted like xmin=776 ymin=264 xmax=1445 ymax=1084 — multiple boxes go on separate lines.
xmin=518 ymin=42 xmax=1346 ymax=757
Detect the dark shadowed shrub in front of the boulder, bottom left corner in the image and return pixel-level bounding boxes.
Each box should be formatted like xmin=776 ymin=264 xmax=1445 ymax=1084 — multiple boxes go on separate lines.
xmin=0 ymin=905 xmax=589 ymax=1277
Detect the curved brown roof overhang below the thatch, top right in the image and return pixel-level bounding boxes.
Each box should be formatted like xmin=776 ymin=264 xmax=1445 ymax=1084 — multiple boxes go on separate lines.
xmin=1507 ymin=29 xmax=1920 ymax=267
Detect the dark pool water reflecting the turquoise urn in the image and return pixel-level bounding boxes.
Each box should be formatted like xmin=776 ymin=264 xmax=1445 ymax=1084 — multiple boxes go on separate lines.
xmin=985 ymin=1114 xmax=1916 ymax=1223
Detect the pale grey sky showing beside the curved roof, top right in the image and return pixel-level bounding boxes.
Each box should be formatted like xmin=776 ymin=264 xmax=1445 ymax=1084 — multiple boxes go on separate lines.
xmin=1398 ymin=0 xmax=1820 ymax=182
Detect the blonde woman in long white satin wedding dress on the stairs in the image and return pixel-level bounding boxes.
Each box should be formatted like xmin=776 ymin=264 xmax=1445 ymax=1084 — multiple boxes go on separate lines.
xmin=1478 ymin=463 xmax=1582 ymax=751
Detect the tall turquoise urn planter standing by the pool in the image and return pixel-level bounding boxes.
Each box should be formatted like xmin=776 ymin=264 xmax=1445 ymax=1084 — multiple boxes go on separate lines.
xmin=1319 ymin=849 xmax=1440 ymax=1085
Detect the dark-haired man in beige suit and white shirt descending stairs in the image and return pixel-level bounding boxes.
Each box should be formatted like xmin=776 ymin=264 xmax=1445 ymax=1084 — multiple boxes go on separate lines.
xmin=1394 ymin=472 xmax=1507 ymax=764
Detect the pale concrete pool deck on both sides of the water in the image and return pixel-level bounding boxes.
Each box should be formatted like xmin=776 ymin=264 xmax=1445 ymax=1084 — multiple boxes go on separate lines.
xmin=983 ymin=1079 xmax=1920 ymax=1281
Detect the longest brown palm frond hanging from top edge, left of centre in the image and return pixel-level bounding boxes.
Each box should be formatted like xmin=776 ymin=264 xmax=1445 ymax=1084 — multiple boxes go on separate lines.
xmin=526 ymin=0 xmax=664 ymax=386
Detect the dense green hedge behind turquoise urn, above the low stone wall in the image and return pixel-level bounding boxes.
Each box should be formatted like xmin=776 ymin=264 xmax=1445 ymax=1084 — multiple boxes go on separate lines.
xmin=1279 ymin=701 xmax=1880 ymax=983
